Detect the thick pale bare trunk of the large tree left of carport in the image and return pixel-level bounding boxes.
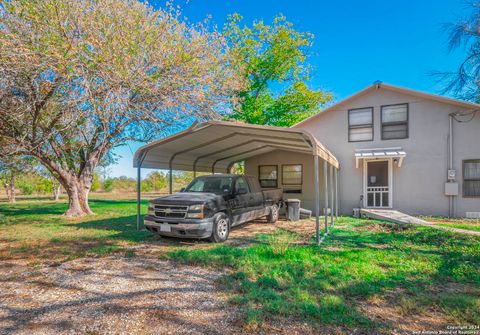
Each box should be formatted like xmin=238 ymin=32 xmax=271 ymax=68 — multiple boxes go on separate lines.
xmin=63 ymin=175 xmax=93 ymax=217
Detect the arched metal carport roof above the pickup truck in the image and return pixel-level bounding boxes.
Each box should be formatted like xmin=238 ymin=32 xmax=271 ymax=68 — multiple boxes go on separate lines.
xmin=133 ymin=121 xmax=339 ymax=172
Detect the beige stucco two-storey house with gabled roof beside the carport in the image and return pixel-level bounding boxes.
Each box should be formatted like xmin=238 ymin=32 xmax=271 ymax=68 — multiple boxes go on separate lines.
xmin=245 ymin=82 xmax=480 ymax=217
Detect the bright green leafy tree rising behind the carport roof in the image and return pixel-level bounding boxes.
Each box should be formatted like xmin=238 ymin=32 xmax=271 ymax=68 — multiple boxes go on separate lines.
xmin=224 ymin=14 xmax=332 ymax=126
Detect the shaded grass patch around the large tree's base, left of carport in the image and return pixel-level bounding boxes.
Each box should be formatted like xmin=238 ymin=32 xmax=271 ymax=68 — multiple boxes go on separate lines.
xmin=0 ymin=199 xmax=151 ymax=259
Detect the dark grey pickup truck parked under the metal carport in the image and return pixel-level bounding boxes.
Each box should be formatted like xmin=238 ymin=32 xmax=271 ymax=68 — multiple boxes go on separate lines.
xmin=144 ymin=174 xmax=283 ymax=242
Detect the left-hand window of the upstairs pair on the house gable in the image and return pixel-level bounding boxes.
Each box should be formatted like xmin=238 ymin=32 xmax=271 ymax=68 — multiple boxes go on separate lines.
xmin=348 ymin=107 xmax=373 ymax=142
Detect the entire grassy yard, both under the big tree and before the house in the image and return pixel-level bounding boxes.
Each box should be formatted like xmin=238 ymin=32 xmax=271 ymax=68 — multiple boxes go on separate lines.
xmin=0 ymin=194 xmax=480 ymax=334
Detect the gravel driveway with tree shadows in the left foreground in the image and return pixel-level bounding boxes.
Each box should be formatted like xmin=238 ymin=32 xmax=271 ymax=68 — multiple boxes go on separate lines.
xmin=0 ymin=256 xmax=242 ymax=334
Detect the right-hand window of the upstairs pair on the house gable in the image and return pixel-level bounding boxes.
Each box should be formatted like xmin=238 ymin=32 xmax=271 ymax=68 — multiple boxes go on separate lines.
xmin=381 ymin=104 xmax=408 ymax=140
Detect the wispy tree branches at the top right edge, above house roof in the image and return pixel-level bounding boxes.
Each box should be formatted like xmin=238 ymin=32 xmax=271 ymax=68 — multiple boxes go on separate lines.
xmin=440 ymin=2 xmax=480 ymax=102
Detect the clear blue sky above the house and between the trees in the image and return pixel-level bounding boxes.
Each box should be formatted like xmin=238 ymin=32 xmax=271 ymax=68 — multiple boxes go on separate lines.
xmin=110 ymin=0 xmax=468 ymax=177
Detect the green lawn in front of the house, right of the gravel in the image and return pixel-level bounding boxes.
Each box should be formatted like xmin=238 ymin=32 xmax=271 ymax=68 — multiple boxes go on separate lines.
xmin=167 ymin=218 xmax=480 ymax=333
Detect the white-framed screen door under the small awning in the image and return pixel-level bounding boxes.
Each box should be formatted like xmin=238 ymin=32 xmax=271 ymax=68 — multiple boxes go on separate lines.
xmin=363 ymin=159 xmax=393 ymax=208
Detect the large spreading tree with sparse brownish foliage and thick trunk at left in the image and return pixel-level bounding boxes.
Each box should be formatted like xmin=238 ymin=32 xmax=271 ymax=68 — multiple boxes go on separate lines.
xmin=0 ymin=0 xmax=242 ymax=216
